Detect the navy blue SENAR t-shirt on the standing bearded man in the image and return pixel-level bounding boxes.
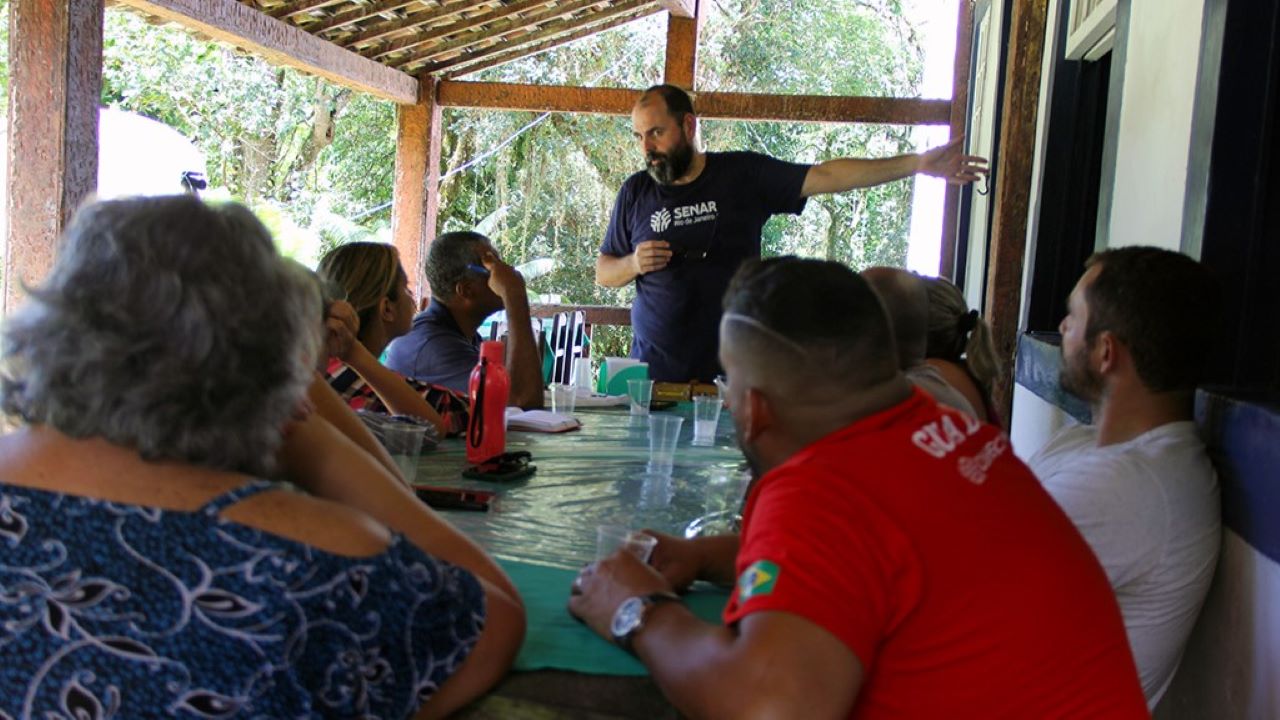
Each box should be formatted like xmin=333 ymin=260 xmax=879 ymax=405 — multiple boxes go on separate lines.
xmin=600 ymin=152 xmax=809 ymax=382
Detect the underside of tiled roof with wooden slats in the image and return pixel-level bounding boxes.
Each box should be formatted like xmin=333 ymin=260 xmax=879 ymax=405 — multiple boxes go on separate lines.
xmin=239 ymin=0 xmax=663 ymax=77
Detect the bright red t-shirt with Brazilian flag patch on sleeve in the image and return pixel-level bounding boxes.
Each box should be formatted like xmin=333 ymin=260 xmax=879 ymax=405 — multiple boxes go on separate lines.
xmin=724 ymin=389 xmax=1147 ymax=717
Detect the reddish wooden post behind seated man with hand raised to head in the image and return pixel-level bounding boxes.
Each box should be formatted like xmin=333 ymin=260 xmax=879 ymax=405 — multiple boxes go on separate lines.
xmin=392 ymin=76 xmax=442 ymax=299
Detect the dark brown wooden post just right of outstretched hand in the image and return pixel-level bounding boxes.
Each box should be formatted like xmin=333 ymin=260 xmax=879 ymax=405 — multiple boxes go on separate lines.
xmin=984 ymin=0 xmax=1048 ymax=418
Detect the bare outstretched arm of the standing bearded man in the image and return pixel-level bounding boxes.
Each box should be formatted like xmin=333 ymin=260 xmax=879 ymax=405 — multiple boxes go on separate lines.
xmin=800 ymin=136 xmax=987 ymax=197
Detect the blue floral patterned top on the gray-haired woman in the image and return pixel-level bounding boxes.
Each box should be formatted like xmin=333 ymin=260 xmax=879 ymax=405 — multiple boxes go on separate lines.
xmin=0 ymin=482 xmax=484 ymax=720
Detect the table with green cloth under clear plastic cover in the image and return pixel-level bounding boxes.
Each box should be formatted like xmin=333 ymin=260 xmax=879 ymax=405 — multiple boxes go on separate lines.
xmin=417 ymin=402 xmax=745 ymax=720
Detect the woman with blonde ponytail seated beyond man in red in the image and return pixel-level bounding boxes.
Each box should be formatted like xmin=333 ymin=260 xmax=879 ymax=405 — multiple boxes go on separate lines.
xmin=924 ymin=271 xmax=1004 ymax=425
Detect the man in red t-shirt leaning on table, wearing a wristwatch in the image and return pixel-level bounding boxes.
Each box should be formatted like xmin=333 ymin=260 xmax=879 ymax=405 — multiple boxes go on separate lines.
xmin=570 ymin=258 xmax=1147 ymax=719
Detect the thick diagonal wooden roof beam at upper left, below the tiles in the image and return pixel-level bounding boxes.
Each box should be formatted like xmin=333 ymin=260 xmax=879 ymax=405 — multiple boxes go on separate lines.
xmin=116 ymin=0 xmax=419 ymax=105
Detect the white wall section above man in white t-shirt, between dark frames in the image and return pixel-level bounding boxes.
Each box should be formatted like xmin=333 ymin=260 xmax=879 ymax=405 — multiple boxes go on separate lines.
xmin=1107 ymin=0 xmax=1204 ymax=250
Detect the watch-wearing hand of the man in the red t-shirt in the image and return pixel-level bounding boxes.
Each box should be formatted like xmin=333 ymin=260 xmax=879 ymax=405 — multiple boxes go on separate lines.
xmin=568 ymin=550 xmax=672 ymax=641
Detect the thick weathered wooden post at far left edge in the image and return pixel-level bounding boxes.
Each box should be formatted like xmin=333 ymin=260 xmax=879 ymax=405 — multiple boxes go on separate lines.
xmin=3 ymin=0 xmax=102 ymax=314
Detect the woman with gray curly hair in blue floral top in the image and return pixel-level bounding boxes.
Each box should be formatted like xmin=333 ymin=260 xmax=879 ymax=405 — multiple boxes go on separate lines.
xmin=0 ymin=197 xmax=525 ymax=717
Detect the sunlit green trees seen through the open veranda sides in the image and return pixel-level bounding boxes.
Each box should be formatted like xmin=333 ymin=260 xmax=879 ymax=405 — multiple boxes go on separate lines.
xmin=0 ymin=0 xmax=923 ymax=313
